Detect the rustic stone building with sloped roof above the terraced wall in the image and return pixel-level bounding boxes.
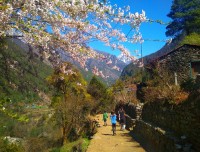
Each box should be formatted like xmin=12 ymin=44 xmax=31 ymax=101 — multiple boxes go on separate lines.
xmin=152 ymin=44 xmax=200 ymax=83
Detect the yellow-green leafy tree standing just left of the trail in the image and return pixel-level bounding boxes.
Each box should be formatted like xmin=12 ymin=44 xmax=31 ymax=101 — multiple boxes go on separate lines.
xmin=47 ymin=63 xmax=91 ymax=144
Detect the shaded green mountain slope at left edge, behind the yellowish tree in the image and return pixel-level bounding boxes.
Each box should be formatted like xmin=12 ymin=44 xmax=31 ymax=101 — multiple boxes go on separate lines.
xmin=0 ymin=39 xmax=53 ymax=102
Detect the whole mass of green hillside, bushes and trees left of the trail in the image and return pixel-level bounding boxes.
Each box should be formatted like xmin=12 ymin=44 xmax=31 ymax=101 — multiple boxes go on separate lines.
xmin=0 ymin=39 xmax=115 ymax=152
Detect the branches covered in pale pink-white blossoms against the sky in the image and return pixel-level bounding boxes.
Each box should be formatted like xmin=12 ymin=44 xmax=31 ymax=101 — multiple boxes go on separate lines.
xmin=0 ymin=0 xmax=147 ymax=77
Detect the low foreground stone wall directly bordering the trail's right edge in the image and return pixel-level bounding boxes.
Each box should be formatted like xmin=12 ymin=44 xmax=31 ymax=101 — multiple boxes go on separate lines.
xmin=132 ymin=120 xmax=181 ymax=152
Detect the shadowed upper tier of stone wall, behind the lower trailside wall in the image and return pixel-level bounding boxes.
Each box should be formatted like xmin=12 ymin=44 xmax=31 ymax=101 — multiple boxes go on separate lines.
xmin=141 ymin=91 xmax=200 ymax=151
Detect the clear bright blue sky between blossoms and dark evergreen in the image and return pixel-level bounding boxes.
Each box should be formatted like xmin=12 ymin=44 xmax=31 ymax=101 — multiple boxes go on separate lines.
xmin=90 ymin=0 xmax=172 ymax=56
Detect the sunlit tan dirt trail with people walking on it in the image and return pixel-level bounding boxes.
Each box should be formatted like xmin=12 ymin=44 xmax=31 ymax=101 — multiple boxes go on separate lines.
xmin=87 ymin=115 xmax=145 ymax=152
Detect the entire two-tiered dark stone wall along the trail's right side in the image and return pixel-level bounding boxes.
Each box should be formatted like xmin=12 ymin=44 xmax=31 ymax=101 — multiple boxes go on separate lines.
xmin=121 ymin=91 xmax=200 ymax=152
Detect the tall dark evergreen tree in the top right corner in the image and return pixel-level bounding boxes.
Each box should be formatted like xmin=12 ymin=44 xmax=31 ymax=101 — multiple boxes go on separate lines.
xmin=166 ymin=0 xmax=200 ymax=37
